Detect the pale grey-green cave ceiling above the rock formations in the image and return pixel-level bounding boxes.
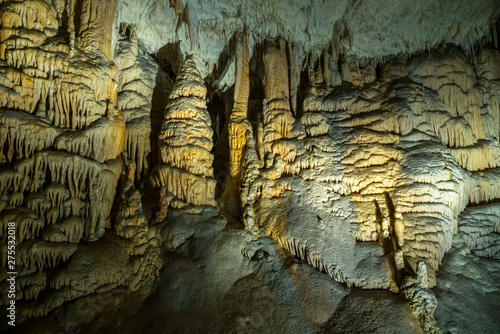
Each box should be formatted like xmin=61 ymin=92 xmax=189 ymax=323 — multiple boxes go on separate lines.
xmin=118 ymin=0 xmax=499 ymax=78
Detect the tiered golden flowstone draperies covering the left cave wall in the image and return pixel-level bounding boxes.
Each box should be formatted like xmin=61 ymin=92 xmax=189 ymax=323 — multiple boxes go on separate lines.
xmin=0 ymin=1 xmax=125 ymax=243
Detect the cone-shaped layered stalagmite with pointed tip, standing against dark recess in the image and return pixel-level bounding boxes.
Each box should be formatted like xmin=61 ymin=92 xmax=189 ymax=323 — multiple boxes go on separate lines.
xmin=152 ymin=57 xmax=216 ymax=208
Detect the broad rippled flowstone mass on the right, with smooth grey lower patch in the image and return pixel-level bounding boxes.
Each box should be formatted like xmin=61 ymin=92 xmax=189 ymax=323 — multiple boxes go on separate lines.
xmin=245 ymin=44 xmax=499 ymax=288
